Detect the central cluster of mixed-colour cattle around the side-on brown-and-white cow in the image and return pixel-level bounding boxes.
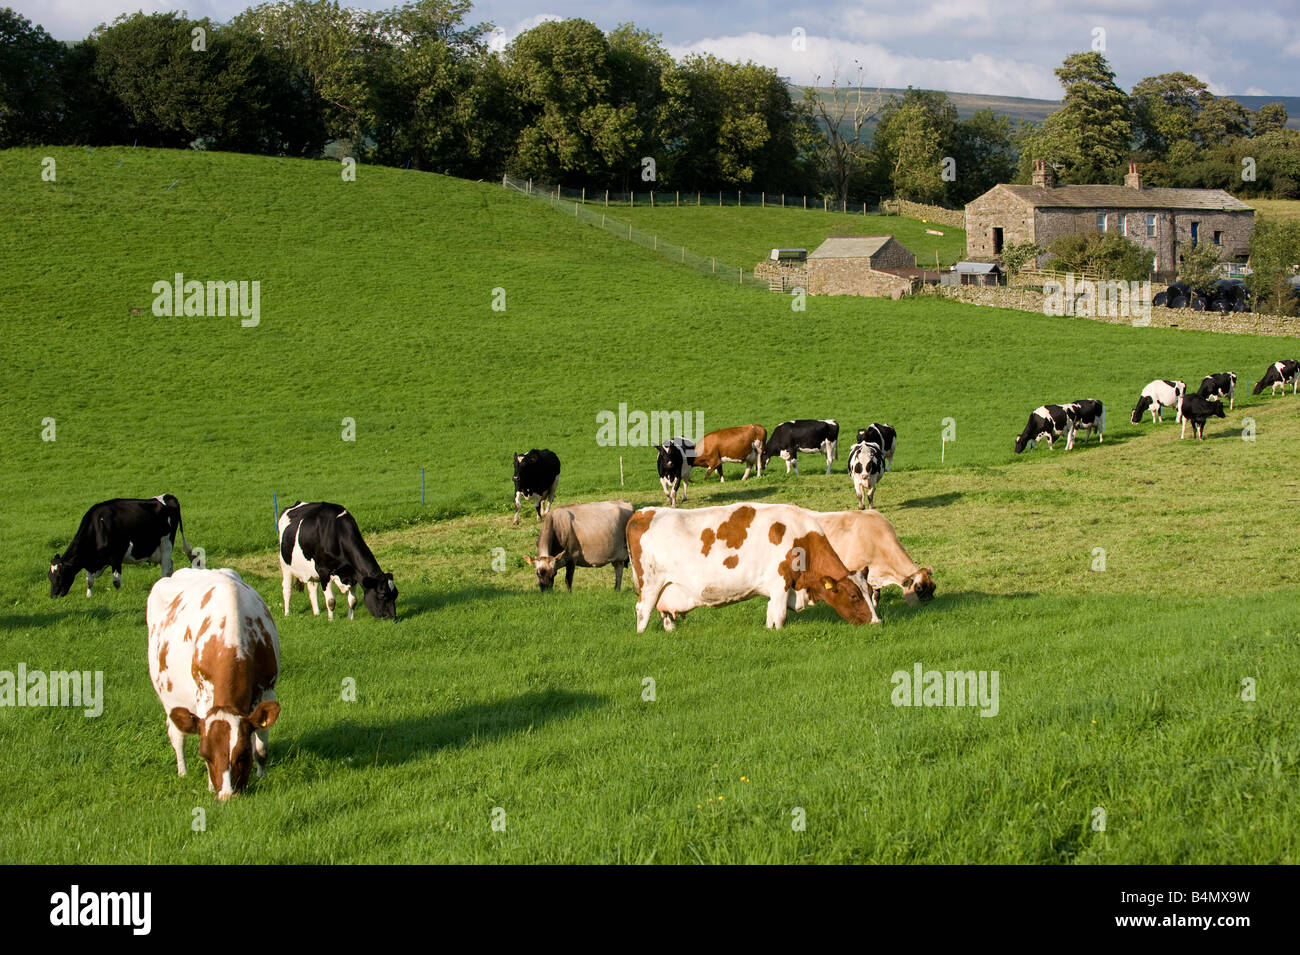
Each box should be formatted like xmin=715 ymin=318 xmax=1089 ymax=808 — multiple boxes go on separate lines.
xmin=514 ymin=418 xmax=935 ymax=633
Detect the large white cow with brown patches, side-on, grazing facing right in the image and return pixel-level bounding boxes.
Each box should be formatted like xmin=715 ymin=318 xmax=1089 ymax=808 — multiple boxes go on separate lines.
xmin=628 ymin=504 xmax=878 ymax=633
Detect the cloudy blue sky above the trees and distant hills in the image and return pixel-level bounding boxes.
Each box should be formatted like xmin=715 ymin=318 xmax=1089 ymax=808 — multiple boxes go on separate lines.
xmin=17 ymin=0 xmax=1300 ymax=99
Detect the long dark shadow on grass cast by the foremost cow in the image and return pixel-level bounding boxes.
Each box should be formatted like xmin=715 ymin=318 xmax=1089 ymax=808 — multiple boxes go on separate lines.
xmin=290 ymin=689 xmax=607 ymax=765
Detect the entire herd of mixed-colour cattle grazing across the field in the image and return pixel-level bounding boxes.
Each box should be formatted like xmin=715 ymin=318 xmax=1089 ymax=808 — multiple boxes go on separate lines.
xmin=40 ymin=359 xmax=1300 ymax=799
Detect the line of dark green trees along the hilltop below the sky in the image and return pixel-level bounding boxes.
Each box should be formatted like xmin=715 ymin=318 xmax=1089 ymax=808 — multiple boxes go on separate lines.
xmin=0 ymin=0 xmax=1300 ymax=208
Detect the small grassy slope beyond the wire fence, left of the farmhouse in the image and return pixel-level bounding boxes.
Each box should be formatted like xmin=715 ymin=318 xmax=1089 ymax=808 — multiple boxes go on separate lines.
xmin=610 ymin=197 xmax=966 ymax=269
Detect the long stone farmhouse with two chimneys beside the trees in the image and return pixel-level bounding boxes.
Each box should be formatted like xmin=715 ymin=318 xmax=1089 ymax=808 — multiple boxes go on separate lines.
xmin=966 ymin=160 xmax=1255 ymax=273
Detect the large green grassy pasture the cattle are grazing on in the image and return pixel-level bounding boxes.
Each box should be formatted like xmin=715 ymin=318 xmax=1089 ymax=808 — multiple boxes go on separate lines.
xmin=0 ymin=143 xmax=1300 ymax=863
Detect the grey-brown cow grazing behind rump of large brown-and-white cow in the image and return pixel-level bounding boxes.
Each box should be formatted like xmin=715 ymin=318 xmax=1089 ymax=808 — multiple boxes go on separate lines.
xmin=524 ymin=500 xmax=632 ymax=590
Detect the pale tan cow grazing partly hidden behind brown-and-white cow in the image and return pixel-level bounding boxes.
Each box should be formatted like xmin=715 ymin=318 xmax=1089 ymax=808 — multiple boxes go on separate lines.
xmin=794 ymin=511 xmax=935 ymax=611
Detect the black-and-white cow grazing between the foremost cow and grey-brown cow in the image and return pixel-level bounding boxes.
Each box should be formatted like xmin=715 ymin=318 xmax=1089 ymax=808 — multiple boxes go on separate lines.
xmin=280 ymin=502 xmax=398 ymax=620
